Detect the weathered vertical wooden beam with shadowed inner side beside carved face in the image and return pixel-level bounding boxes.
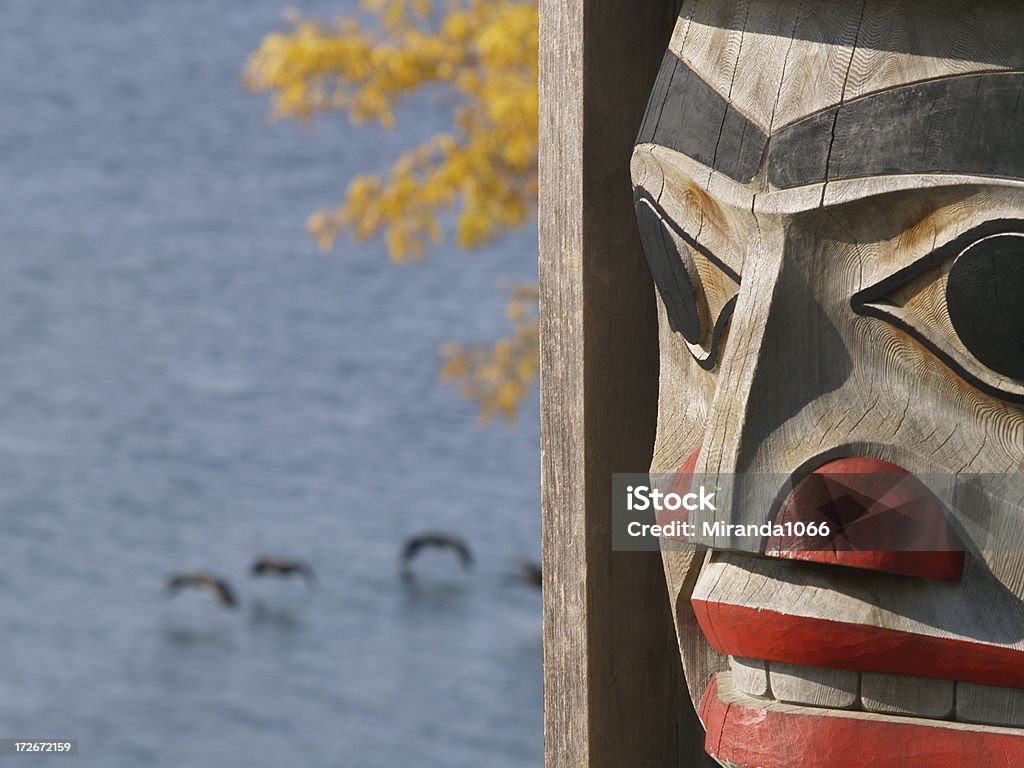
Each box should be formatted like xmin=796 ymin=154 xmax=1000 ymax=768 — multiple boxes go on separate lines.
xmin=540 ymin=0 xmax=696 ymax=768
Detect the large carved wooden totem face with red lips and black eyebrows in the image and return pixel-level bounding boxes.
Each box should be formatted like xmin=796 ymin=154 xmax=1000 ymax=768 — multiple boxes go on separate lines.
xmin=632 ymin=0 xmax=1024 ymax=768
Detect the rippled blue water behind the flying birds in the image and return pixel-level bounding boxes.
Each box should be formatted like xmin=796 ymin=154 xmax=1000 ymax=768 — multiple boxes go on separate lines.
xmin=0 ymin=0 xmax=542 ymax=768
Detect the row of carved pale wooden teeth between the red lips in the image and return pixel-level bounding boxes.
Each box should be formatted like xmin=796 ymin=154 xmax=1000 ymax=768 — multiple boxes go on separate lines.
xmin=729 ymin=656 xmax=1024 ymax=728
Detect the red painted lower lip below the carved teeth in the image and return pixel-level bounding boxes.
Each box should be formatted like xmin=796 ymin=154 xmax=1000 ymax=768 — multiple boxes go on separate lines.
xmin=700 ymin=681 xmax=1024 ymax=768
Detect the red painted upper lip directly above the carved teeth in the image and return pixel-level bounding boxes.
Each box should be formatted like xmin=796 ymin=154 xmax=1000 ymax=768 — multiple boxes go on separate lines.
xmin=692 ymin=599 xmax=1024 ymax=696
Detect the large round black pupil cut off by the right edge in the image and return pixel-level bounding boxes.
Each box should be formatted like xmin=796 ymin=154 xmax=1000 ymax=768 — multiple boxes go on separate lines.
xmin=946 ymin=234 xmax=1024 ymax=379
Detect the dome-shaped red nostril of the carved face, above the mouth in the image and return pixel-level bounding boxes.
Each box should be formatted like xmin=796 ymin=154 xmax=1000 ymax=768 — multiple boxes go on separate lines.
xmin=765 ymin=458 xmax=964 ymax=582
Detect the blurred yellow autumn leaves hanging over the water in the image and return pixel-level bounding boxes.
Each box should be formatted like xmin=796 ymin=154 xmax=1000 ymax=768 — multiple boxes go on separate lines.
xmin=244 ymin=0 xmax=538 ymax=420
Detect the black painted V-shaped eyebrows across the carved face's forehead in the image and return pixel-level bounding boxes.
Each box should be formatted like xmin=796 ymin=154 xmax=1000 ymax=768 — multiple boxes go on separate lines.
xmin=637 ymin=51 xmax=1024 ymax=189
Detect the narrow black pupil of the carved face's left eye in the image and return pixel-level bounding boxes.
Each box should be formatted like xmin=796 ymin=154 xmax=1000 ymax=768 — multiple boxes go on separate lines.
xmin=636 ymin=200 xmax=708 ymax=344
